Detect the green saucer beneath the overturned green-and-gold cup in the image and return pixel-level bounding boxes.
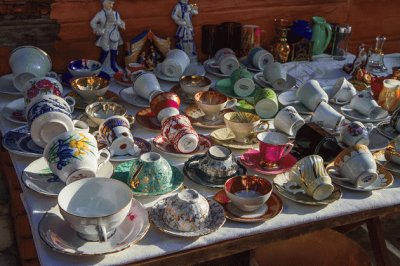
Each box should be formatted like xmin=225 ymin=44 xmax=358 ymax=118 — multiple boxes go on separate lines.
xmin=112 ymin=160 xmax=184 ymax=197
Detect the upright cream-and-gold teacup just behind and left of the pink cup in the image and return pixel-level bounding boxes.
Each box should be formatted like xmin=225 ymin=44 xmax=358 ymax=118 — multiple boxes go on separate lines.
xmin=224 ymin=112 xmax=269 ymax=143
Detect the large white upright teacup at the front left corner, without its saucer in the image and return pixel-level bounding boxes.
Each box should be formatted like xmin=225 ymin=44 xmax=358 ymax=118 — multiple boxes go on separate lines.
xmin=57 ymin=177 xmax=132 ymax=242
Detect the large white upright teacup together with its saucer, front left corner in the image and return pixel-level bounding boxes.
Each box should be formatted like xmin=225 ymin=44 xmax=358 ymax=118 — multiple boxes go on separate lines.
xmin=38 ymin=178 xmax=150 ymax=256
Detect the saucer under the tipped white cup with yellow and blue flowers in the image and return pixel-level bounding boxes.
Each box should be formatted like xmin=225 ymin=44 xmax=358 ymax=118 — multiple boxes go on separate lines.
xmin=21 ymin=157 xmax=114 ymax=197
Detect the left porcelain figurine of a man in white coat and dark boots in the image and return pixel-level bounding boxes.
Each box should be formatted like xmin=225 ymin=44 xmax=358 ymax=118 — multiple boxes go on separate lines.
xmin=90 ymin=0 xmax=125 ymax=75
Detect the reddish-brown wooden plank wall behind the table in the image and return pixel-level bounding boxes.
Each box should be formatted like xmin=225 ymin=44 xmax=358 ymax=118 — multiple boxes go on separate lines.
xmin=0 ymin=0 xmax=400 ymax=73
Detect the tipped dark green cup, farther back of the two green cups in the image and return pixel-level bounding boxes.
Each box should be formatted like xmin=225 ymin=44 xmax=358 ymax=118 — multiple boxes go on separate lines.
xmin=231 ymin=67 xmax=256 ymax=97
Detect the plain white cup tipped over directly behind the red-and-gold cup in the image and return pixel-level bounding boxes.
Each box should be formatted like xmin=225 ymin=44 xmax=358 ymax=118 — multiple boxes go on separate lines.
xmin=133 ymin=72 xmax=163 ymax=100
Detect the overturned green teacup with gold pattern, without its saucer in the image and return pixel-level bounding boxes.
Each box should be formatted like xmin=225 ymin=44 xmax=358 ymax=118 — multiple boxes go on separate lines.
xmin=128 ymin=152 xmax=172 ymax=193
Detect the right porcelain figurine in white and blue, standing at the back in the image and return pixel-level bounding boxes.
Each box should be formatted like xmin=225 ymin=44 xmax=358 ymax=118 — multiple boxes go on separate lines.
xmin=171 ymin=0 xmax=199 ymax=58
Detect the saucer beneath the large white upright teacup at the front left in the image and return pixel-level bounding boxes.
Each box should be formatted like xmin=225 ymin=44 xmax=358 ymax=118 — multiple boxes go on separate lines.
xmin=38 ymin=198 xmax=150 ymax=256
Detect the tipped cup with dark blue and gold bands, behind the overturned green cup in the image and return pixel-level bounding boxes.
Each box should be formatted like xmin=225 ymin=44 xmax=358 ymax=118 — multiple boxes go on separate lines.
xmin=94 ymin=115 xmax=136 ymax=156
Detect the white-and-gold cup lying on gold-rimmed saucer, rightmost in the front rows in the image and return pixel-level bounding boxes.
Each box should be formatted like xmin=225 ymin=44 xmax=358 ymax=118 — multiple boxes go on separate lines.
xmin=327 ymin=144 xmax=394 ymax=191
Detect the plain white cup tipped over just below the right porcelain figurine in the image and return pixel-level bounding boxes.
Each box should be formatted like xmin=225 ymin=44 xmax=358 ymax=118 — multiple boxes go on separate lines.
xmin=161 ymin=49 xmax=190 ymax=78
